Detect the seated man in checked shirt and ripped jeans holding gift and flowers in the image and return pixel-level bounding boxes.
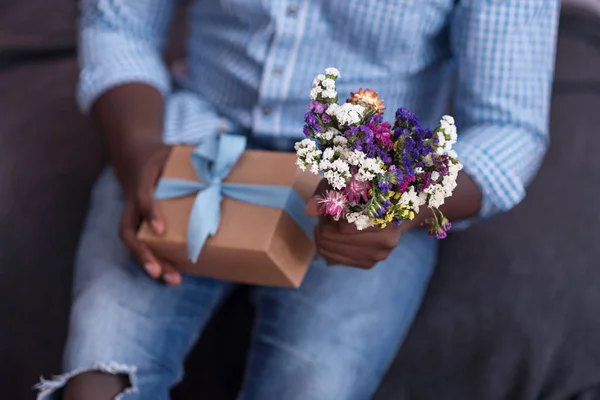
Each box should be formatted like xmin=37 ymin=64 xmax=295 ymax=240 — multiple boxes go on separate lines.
xmin=40 ymin=0 xmax=559 ymax=400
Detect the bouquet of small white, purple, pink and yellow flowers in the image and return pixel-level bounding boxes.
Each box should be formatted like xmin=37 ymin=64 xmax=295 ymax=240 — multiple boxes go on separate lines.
xmin=295 ymin=68 xmax=462 ymax=239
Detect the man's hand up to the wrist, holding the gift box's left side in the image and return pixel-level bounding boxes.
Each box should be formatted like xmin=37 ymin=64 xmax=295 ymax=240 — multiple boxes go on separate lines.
xmin=117 ymin=144 xmax=181 ymax=285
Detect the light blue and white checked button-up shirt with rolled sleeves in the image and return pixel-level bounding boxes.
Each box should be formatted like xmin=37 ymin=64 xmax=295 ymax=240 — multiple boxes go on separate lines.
xmin=78 ymin=0 xmax=560 ymax=217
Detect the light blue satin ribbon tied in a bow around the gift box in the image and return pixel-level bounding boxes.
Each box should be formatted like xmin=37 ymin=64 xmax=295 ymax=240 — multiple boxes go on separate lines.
xmin=155 ymin=134 xmax=315 ymax=262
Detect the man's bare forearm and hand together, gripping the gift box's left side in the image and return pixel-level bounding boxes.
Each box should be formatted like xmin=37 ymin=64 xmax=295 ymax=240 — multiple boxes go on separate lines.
xmin=92 ymin=83 xmax=181 ymax=285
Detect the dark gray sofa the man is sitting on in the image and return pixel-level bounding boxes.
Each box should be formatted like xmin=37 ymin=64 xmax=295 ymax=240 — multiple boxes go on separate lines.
xmin=0 ymin=0 xmax=600 ymax=400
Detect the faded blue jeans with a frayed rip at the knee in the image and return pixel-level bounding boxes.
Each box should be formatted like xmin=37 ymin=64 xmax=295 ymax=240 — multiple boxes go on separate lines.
xmin=38 ymin=170 xmax=437 ymax=400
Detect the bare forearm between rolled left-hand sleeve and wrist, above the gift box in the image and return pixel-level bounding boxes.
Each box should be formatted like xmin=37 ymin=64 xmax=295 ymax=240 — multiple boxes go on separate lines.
xmin=92 ymin=83 xmax=164 ymax=183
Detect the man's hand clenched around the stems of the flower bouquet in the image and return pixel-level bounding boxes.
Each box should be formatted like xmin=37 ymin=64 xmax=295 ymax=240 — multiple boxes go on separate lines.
xmin=306 ymin=180 xmax=403 ymax=269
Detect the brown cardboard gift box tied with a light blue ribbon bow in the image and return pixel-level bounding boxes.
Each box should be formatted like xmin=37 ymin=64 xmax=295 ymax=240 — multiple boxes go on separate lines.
xmin=138 ymin=135 xmax=321 ymax=287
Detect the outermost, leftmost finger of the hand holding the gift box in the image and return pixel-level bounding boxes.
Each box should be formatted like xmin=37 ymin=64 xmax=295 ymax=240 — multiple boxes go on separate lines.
xmin=120 ymin=203 xmax=162 ymax=278
